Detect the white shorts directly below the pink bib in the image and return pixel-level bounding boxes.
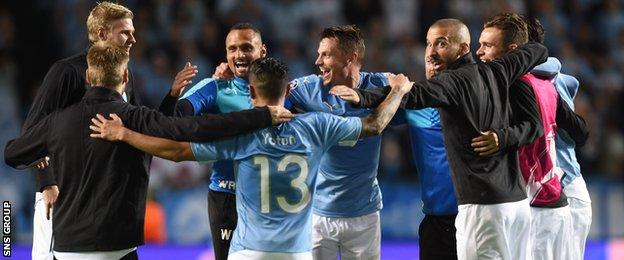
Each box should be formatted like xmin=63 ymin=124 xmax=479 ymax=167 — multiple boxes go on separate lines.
xmin=531 ymin=206 xmax=572 ymax=260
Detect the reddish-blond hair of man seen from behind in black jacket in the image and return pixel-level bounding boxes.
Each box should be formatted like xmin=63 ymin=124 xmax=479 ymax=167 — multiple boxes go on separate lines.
xmin=87 ymin=42 xmax=129 ymax=88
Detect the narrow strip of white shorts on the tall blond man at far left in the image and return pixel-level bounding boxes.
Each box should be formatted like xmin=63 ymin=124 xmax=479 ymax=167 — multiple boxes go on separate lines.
xmin=32 ymin=192 xmax=54 ymax=260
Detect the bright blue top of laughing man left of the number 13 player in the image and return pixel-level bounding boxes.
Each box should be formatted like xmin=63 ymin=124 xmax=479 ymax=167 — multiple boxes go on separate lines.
xmin=180 ymin=78 xmax=252 ymax=193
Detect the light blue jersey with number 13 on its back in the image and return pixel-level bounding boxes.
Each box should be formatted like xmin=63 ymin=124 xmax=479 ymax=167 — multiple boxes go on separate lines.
xmin=191 ymin=113 xmax=362 ymax=253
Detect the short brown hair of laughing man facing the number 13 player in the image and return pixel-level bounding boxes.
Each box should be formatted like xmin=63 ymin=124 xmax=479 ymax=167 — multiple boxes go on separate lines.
xmin=321 ymin=25 xmax=366 ymax=62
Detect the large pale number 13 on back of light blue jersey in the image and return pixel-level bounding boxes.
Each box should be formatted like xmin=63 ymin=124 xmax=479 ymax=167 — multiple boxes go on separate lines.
xmin=254 ymin=154 xmax=310 ymax=213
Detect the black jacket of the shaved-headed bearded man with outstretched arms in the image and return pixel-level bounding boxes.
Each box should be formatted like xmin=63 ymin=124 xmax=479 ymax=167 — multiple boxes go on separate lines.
xmin=358 ymin=43 xmax=548 ymax=205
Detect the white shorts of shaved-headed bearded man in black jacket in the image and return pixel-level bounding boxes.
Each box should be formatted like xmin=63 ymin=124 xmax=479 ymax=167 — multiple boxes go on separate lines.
xmin=455 ymin=199 xmax=531 ymax=260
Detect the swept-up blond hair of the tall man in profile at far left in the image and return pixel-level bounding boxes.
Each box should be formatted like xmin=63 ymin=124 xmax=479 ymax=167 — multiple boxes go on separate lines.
xmin=87 ymin=2 xmax=134 ymax=43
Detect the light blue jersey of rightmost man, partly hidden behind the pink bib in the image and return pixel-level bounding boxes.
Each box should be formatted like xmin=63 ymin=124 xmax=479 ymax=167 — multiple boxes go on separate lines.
xmin=531 ymin=57 xmax=581 ymax=187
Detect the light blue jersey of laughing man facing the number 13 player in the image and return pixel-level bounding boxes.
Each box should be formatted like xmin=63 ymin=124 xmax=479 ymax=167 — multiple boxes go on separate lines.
xmin=288 ymin=72 xmax=388 ymax=217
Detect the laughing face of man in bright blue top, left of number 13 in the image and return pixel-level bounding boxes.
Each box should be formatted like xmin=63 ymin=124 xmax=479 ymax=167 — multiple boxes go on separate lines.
xmin=225 ymin=29 xmax=266 ymax=79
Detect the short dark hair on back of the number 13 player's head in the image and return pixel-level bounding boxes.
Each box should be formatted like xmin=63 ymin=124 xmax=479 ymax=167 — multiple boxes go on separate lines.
xmin=249 ymin=57 xmax=288 ymax=100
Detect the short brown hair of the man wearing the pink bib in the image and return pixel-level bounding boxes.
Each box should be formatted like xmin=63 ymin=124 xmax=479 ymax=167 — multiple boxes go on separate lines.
xmin=483 ymin=13 xmax=529 ymax=45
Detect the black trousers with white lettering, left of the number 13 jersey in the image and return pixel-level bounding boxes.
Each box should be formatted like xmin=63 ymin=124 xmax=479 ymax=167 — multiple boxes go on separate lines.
xmin=208 ymin=190 xmax=238 ymax=260
